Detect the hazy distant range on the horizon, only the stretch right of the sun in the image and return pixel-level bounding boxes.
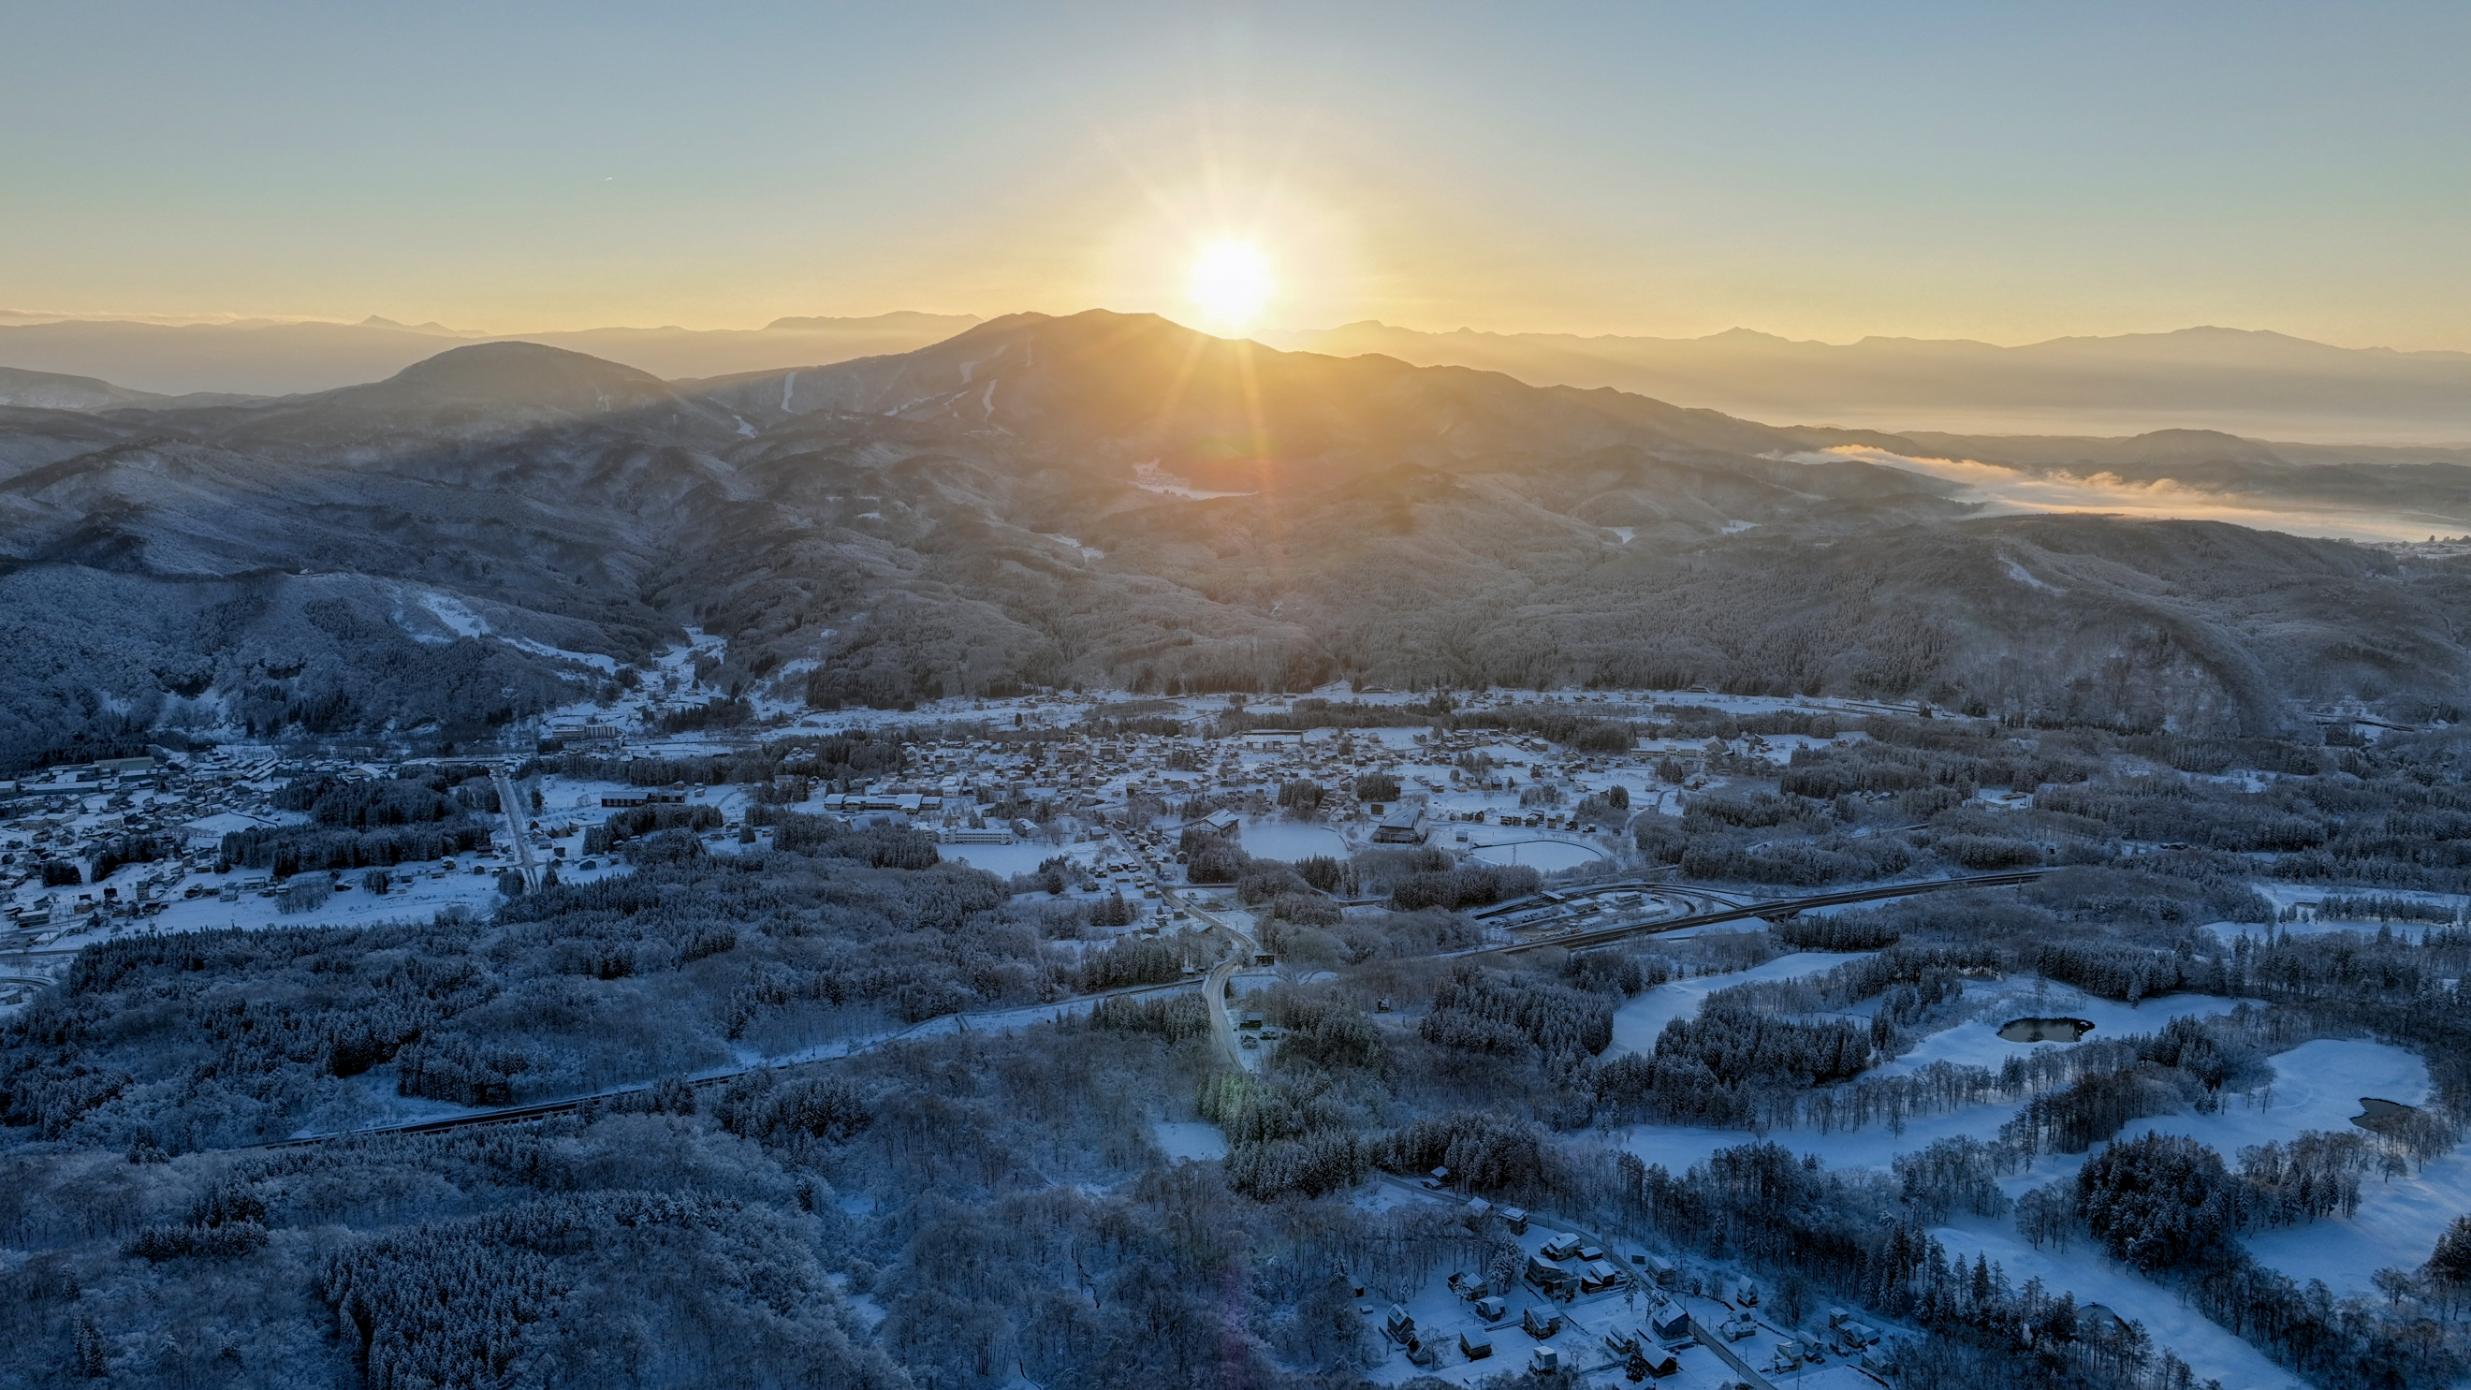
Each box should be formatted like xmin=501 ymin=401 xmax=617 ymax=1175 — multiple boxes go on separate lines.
xmin=1282 ymin=321 xmax=2471 ymax=444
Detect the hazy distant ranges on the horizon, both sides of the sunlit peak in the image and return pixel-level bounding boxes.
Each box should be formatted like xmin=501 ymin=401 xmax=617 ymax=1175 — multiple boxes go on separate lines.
xmin=0 ymin=311 xmax=2471 ymax=444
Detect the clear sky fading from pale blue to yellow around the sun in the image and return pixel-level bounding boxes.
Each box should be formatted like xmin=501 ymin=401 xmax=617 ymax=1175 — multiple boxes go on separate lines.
xmin=0 ymin=0 xmax=2471 ymax=348
